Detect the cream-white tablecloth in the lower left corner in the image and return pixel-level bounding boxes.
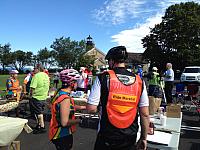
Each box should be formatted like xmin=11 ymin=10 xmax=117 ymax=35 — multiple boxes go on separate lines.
xmin=0 ymin=116 xmax=28 ymax=146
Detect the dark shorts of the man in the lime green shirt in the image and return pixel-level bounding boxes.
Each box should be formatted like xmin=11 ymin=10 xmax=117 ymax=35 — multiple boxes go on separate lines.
xmin=30 ymin=98 xmax=45 ymax=115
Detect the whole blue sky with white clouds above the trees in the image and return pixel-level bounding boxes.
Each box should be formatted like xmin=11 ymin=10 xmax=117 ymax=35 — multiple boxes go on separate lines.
xmin=0 ymin=0 xmax=200 ymax=54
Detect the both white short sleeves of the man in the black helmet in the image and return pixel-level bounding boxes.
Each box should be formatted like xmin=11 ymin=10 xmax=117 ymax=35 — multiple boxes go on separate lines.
xmin=87 ymin=77 xmax=149 ymax=107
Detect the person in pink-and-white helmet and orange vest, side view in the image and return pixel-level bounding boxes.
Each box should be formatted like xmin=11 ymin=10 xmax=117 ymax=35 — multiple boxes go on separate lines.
xmin=49 ymin=69 xmax=83 ymax=150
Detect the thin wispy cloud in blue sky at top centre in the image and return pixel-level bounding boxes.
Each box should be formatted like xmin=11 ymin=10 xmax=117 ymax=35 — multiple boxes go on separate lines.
xmin=93 ymin=0 xmax=151 ymax=25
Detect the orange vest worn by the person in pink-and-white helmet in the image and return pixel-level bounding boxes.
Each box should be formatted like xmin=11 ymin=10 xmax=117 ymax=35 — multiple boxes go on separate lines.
xmin=49 ymin=94 xmax=76 ymax=140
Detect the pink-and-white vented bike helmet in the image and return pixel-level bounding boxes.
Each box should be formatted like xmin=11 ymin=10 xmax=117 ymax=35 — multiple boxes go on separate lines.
xmin=60 ymin=69 xmax=80 ymax=83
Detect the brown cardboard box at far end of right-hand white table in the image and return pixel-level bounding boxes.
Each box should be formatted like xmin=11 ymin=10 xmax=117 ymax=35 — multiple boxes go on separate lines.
xmin=166 ymin=104 xmax=181 ymax=118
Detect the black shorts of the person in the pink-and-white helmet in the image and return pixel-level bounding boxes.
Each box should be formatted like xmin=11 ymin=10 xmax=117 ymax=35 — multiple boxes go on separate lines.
xmin=52 ymin=135 xmax=73 ymax=150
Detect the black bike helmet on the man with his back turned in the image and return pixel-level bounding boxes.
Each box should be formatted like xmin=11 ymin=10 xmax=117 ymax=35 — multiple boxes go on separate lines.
xmin=105 ymin=46 xmax=128 ymax=61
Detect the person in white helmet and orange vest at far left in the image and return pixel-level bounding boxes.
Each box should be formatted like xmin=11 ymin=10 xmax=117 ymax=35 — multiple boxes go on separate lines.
xmin=6 ymin=70 xmax=22 ymax=100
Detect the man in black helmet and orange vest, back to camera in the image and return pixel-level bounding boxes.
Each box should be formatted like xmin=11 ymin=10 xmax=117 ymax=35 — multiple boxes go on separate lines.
xmin=86 ymin=46 xmax=149 ymax=150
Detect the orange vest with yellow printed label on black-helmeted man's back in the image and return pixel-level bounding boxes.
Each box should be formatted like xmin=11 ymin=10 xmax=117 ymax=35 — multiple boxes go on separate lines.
xmin=106 ymin=70 xmax=142 ymax=129
